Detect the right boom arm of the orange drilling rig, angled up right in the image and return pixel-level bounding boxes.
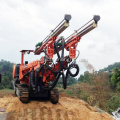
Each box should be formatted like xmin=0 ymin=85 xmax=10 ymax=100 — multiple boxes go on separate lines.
xmin=56 ymin=15 xmax=100 ymax=58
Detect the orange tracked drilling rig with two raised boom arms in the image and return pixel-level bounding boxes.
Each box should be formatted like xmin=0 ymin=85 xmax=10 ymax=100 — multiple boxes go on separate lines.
xmin=13 ymin=15 xmax=100 ymax=104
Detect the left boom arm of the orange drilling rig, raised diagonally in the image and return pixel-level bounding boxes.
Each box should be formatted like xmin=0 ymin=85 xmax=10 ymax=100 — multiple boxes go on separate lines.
xmin=34 ymin=15 xmax=71 ymax=58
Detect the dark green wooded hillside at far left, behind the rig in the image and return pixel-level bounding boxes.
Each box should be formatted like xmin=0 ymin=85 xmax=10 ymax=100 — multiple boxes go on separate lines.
xmin=0 ymin=60 xmax=13 ymax=89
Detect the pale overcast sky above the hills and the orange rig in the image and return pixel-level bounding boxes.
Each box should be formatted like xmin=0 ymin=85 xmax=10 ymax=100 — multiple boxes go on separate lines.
xmin=0 ymin=0 xmax=120 ymax=74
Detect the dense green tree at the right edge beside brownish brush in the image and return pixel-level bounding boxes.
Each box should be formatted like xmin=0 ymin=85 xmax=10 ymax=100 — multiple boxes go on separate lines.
xmin=111 ymin=68 xmax=120 ymax=91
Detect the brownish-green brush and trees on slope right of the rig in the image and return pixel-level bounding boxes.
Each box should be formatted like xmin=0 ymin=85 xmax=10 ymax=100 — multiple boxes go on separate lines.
xmin=66 ymin=63 xmax=120 ymax=113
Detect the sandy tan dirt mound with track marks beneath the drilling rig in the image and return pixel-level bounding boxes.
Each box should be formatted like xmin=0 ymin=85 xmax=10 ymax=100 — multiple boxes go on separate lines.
xmin=0 ymin=96 xmax=113 ymax=120
